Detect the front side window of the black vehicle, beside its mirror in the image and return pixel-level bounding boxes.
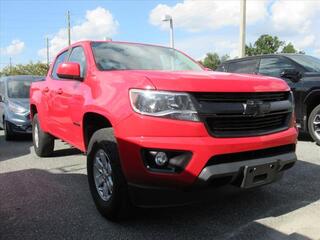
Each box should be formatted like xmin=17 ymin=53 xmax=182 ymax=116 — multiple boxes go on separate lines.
xmin=259 ymin=57 xmax=295 ymax=77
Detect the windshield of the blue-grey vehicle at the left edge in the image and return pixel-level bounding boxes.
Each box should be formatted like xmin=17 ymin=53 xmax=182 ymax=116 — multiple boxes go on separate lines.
xmin=8 ymin=80 xmax=31 ymax=98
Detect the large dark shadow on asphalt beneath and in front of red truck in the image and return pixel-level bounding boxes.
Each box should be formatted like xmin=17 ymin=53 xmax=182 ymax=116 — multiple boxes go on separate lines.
xmin=0 ymin=158 xmax=320 ymax=240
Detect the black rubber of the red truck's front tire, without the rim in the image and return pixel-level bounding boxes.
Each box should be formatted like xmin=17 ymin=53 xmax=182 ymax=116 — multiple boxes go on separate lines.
xmin=87 ymin=128 xmax=132 ymax=221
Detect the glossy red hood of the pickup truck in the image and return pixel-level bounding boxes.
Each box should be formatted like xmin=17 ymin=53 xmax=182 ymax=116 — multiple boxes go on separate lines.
xmin=124 ymin=71 xmax=290 ymax=92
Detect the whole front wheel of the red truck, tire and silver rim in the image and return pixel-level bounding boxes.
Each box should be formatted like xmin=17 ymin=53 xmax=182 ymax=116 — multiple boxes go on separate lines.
xmin=87 ymin=128 xmax=131 ymax=221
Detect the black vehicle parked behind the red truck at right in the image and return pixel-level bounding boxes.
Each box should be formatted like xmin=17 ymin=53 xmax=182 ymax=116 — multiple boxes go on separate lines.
xmin=217 ymin=54 xmax=320 ymax=144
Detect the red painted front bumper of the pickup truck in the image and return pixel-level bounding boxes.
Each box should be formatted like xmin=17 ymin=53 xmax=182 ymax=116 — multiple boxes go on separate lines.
xmin=115 ymin=115 xmax=297 ymax=189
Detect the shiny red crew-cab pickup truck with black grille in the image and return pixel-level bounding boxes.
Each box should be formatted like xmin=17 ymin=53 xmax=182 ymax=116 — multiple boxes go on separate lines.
xmin=30 ymin=41 xmax=297 ymax=219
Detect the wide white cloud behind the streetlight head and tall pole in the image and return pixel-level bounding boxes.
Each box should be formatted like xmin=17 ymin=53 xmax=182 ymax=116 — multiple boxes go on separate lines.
xmin=149 ymin=0 xmax=268 ymax=32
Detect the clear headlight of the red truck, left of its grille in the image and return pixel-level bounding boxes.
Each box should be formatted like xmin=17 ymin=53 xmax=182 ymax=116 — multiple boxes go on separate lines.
xmin=129 ymin=89 xmax=199 ymax=121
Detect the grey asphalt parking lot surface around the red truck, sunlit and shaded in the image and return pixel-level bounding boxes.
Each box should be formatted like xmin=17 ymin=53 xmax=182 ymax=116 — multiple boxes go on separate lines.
xmin=0 ymin=131 xmax=320 ymax=240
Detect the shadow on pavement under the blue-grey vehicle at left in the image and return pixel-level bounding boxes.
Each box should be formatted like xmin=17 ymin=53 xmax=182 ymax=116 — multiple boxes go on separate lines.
xmin=0 ymin=130 xmax=33 ymax=162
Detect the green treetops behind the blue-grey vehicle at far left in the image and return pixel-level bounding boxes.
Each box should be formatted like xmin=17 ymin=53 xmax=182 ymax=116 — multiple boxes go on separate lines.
xmin=0 ymin=62 xmax=49 ymax=76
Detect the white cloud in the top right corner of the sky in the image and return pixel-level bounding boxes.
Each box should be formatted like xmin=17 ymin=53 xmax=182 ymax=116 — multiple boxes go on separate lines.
xmin=271 ymin=0 xmax=320 ymax=33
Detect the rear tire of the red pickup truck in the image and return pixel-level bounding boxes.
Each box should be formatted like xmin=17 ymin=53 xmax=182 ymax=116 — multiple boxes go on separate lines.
xmin=32 ymin=114 xmax=54 ymax=157
